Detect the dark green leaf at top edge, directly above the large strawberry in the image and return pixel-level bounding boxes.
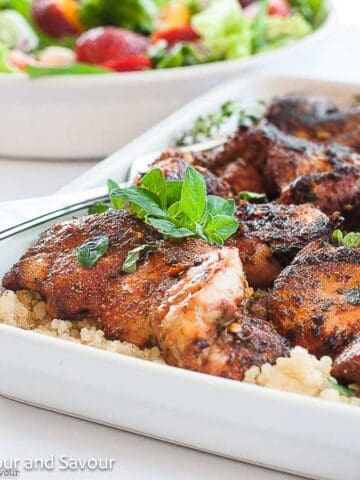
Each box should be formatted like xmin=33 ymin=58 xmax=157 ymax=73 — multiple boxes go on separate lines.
xmin=79 ymin=0 xmax=157 ymax=34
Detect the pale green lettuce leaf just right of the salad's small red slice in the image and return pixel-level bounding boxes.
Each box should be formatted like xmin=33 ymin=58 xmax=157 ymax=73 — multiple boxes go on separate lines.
xmin=191 ymin=0 xmax=252 ymax=60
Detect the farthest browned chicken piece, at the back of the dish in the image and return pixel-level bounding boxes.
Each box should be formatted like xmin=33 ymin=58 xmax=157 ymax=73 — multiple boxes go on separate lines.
xmin=266 ymin=94 xmax=360 ymax=151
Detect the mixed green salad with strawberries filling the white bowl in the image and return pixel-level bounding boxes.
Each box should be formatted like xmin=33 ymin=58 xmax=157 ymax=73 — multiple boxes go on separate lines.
xmin=0 ymin=0 xmax=327 ymax=77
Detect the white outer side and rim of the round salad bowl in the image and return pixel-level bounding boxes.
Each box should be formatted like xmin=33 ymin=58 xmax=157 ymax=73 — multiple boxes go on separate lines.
xmin=0 ymin=4 xmax=334 ymax=159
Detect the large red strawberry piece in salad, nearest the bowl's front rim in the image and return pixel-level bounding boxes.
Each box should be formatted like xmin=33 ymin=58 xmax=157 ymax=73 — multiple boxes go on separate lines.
xmin=75 ymin=27 xmax=148 ymax=65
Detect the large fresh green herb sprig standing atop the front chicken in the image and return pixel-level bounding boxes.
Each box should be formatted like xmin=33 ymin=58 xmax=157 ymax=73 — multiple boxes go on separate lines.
xmin=108 ymin=167 xmax=238 ymax=245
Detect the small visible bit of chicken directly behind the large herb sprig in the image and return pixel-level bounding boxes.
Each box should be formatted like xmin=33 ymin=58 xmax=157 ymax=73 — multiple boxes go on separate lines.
xmin=147 ymin=150 xmax=232 ymax=197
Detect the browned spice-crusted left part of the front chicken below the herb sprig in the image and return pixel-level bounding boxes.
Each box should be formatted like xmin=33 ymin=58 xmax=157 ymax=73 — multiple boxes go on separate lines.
xmin=3 ymin=210 xmax=213 ymax=346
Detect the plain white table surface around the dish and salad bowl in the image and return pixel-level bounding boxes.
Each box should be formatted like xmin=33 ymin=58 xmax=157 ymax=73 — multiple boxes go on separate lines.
xmin=0 ymin=0 xmax=360 ymax=480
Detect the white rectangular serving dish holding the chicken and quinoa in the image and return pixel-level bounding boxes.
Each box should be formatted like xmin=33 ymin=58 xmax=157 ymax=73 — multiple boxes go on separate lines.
xmin=0 ymin=78 xmax=360 ymax=480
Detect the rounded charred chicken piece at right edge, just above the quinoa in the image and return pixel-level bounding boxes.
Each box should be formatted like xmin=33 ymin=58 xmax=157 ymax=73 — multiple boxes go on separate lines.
xmin=268 ymin=242 xmax=360 ymax=357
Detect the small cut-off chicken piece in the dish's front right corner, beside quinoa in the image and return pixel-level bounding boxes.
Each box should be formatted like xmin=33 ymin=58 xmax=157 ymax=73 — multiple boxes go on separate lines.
xmin=331 ymin=337 xmax=360 ymax=385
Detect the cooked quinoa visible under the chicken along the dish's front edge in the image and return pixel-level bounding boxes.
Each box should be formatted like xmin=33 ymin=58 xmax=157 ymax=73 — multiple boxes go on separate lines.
xmin=0 ymin=290 xmax=360 ymax=406
